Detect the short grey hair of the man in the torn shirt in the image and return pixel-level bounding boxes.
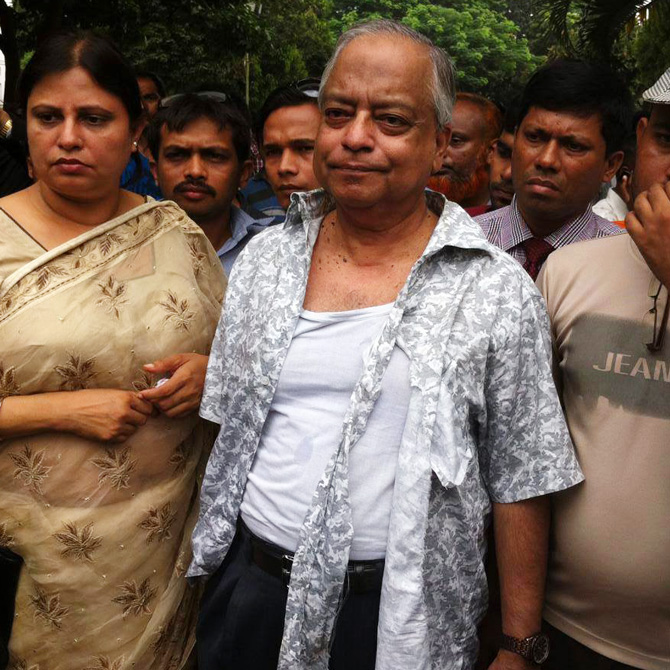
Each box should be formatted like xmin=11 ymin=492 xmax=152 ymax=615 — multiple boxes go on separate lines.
xmin=319 ymin=19 xmax=456 ymax=128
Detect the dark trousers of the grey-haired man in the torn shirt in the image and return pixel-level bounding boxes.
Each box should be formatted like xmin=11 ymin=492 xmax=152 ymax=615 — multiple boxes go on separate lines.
xmin=196 ymin=529 xmax=380 ymax=670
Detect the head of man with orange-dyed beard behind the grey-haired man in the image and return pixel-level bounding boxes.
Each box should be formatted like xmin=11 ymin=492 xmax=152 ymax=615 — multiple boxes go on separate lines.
xmin=428 ymin=93 xmax=502 ymax=216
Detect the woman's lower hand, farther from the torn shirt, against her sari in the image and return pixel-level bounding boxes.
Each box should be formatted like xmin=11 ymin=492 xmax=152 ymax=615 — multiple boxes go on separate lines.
xmin=54 ymin=389 xmax=153 ymax=442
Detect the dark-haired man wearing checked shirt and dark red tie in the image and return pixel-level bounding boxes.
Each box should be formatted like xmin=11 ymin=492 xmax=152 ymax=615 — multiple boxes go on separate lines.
xmin=477 ymin=60 xmax=632 ymax=279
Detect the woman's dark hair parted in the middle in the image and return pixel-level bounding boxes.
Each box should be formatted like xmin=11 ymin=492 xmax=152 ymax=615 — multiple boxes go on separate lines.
xmin=19 ymin=31 xmax=143 ymax=125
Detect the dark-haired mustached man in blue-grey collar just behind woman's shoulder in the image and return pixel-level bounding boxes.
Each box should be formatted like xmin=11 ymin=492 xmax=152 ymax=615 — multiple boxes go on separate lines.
xmin=149 ymin=91 xmax=273 ymax=275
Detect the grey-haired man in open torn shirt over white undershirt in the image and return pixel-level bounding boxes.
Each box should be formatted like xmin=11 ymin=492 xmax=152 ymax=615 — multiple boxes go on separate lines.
xmin=189 ymin=20 xmax=582 ymax=670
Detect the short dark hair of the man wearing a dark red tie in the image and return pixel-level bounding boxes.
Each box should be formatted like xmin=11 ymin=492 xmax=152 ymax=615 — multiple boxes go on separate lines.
xmin=518 ymin=59 xmax=633 ymax=156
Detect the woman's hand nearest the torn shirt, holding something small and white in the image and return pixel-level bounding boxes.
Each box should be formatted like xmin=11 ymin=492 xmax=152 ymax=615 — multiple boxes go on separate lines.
xmin=139 ymin=354 xmax=209 ymax=418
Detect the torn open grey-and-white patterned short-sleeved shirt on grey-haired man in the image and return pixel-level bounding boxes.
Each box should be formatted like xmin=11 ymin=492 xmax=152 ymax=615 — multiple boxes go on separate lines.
xmin=189 ymin=191 xmax=582 ymax=670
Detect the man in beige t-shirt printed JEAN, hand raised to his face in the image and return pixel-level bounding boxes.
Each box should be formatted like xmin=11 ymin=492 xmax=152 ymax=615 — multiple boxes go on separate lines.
xmin=538 ymin=70 xmax=670 ymax=670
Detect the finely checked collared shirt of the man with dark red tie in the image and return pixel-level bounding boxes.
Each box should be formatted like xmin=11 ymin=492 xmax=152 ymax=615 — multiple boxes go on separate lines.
xmin=475 ymin=196 xmax=621 ymax=265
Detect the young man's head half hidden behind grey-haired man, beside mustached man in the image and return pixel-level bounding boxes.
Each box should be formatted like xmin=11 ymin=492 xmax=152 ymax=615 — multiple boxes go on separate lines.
xmin=256 ymin=78 xmax=321 ymax=209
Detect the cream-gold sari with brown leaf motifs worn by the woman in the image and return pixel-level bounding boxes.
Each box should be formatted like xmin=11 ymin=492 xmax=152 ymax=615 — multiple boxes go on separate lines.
xmin=0 ymin=202 xmax=225 ymax=670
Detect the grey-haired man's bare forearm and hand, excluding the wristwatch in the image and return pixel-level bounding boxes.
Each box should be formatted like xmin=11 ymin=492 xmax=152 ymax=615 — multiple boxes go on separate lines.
xmin=490 ymin=496 xmax=550 ymax=670
